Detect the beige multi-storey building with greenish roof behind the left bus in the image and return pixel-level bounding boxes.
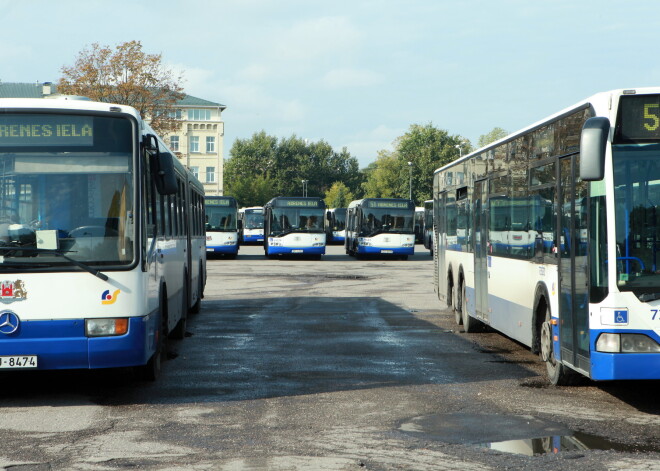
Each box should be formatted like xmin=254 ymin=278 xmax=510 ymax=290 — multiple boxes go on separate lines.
xmin=0 ymin=82 xmax=226 ymax=196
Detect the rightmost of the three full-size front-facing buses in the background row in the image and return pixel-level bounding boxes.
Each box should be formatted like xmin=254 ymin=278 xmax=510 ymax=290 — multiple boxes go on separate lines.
xmin=344 ymin=198 xmax=415 ymax=260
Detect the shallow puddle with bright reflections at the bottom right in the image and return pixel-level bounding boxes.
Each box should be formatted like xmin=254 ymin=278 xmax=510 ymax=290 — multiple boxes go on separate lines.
xmin=482 ymin=432 xmax=659 ymax=456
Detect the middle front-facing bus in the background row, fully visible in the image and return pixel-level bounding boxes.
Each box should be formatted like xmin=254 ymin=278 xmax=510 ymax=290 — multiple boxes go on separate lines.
xmin=264 ymin=196 xmax=325 ymax=260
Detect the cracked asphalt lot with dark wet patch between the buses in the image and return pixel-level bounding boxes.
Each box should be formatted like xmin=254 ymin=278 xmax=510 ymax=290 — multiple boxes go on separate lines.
xmin=0 ymin=246 xmax=660 ymax=471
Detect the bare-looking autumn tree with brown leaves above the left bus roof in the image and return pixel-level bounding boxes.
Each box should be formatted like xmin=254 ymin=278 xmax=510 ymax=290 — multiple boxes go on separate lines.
xmin=57 ymin=41 xmax=185 ymax=135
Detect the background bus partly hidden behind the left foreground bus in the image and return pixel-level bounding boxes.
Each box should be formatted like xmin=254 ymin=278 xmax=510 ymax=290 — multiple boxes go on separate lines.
xmin=204 ymin=196 xmax=238 ymax=258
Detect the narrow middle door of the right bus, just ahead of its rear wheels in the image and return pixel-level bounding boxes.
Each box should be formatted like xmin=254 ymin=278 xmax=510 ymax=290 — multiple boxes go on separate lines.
xmin=472 ymin=180 xmax=489 ymax=322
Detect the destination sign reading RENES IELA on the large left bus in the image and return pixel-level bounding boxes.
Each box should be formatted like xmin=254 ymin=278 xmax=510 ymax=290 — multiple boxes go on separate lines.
xmin=0 ymin=114 xmax=94 ymax=147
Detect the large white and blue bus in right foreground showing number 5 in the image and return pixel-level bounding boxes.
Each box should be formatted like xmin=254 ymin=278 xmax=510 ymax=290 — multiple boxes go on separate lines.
xmin=434 ymin=88 xmax=660 ymax=384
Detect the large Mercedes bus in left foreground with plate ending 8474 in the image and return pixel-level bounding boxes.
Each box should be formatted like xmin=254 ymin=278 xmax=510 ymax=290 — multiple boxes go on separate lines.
xmin=0 ymin=98 xmax=206 ymax=380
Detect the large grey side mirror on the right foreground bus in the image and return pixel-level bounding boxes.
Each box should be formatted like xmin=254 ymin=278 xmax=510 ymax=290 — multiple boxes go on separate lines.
xmin=580 ymin=117 xmax=610 ymax=182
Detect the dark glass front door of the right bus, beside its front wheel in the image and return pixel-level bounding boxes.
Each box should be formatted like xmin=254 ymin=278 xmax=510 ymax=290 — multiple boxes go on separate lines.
xmin=558 ymin=154 xmax=590 ymax=374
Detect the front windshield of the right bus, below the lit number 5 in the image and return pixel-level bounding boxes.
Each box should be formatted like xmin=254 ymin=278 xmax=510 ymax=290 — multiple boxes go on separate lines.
xmin=612 ymin=144 xmax=660 ymax=300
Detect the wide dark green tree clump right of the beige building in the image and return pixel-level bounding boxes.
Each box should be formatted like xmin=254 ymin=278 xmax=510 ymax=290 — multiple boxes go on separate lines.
xmin=224 ymin=131 xmax=361 ymax=206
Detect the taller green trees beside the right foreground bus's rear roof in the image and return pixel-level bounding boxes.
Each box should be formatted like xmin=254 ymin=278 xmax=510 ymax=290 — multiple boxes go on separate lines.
xmin=363 ymin=123 xmax=471 ymax=205
